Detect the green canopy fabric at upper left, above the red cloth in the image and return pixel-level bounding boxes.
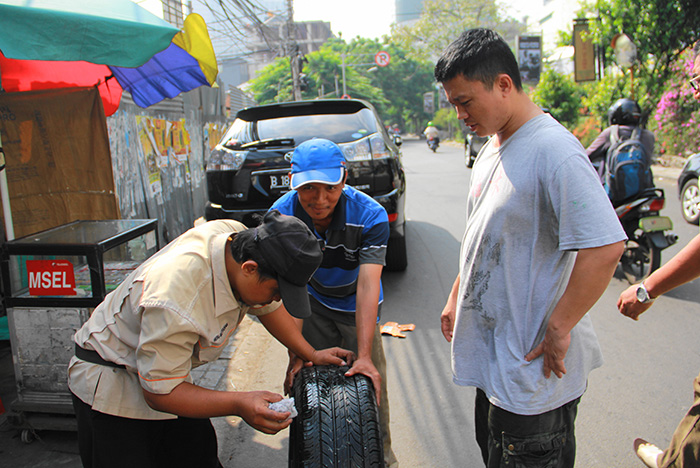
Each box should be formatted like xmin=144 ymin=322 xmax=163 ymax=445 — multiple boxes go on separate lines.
xmin=0 ymin=0 xmax=179 ymax=67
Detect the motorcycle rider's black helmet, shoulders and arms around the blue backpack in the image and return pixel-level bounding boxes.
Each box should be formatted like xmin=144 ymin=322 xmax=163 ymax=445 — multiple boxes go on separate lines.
xmin=586 ymin=98 xmax=654 ymax=181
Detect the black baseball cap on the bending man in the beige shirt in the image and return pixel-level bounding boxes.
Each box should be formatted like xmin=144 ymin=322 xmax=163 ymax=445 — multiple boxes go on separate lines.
xmin=255 ymin=210 xmax=323 ymax=318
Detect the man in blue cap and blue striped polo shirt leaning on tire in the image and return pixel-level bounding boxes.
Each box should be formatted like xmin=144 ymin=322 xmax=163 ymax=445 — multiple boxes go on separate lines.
xmin=271 ymin=138 xmax=398 ymax=468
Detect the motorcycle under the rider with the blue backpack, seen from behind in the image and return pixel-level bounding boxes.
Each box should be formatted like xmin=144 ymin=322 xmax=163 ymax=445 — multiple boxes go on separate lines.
xmin=615 ymin=187 xmax=678 ymax=284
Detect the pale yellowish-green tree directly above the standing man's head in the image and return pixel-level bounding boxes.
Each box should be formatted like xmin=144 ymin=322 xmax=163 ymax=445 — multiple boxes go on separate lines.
xmin=392 ymin=0 xmax=525 ymax=61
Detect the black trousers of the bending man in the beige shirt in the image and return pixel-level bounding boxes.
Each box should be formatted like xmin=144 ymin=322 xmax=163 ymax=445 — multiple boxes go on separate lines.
xmin=73 ymin=395 xmax=221 ymax=468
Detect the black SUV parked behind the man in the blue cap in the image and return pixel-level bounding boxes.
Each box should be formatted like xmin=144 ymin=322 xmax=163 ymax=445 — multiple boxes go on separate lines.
xmin=205 ymin=99 xmax=407 ymax=271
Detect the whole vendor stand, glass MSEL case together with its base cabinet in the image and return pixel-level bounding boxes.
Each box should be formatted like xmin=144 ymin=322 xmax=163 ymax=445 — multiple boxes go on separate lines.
xmin=2 ymin=219 xmax=159 ymax=430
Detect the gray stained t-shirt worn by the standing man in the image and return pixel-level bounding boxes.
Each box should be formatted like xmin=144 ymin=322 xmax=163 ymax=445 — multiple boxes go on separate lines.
xmin=452 ymin=114 xmax=626 ymax=415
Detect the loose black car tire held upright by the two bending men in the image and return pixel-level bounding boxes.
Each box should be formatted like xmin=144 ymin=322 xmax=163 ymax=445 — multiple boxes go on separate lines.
xmin=289 ymin=366 xmax=384 ymax=468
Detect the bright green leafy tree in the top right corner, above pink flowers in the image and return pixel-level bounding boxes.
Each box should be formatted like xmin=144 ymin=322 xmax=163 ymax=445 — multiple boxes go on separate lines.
xmin=584 ymin=0 xmax=700 ymax=110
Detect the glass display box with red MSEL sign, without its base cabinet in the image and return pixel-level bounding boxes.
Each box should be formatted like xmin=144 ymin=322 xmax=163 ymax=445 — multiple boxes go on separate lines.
xmin=3 ymin=219 xmax=158 ymax=307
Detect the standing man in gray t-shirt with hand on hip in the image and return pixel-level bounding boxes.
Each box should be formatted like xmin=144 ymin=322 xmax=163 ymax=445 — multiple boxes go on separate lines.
xmin=435 ymin=29 xmax=625 ymax=468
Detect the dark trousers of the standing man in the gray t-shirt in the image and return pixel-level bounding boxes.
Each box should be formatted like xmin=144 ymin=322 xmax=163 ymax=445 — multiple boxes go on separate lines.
xmin=474 ymin=389 xmax=580 ymax=468
